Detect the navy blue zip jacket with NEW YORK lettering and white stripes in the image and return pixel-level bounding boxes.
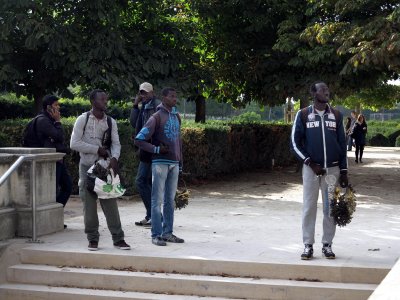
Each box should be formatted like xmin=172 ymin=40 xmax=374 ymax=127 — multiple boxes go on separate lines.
xmin=290 ymin=105 xmax=347 ymax=170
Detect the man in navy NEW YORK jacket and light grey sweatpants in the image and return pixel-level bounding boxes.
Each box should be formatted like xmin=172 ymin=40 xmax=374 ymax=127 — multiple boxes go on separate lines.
xmin=290 ymin=81 xmax=348 ymax=260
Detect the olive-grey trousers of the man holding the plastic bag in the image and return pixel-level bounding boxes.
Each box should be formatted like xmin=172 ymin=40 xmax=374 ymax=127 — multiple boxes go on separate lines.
xmin=79 ymin=164 xmax=124 ymax=243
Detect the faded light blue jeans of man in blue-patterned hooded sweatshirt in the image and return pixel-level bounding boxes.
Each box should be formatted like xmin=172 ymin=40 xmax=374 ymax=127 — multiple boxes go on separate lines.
xmin=151 ymin=164 xmax=179 ymax=238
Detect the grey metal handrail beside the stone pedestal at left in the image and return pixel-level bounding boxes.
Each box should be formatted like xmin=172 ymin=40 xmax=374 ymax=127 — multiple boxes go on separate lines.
xmin=0 ymin=154 xmax=42 ymax=243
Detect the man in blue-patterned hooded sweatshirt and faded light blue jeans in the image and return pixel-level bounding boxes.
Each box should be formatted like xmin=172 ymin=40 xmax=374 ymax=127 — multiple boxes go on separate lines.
xmin=135 ymin=88 xmax=184 ymax=246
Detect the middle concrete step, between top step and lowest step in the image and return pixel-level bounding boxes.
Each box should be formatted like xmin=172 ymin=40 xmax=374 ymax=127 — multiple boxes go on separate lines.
xmin=7 ymin=264 xmax=377 ymax=300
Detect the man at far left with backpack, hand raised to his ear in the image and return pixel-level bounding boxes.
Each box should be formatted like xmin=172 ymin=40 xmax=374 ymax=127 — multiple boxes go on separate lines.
xmin=23 ymin=95 xmax=72 ymax=217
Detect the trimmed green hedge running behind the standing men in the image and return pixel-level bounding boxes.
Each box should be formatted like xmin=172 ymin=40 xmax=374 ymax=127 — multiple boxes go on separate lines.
xmin=0 ymin=118 xmax=295 ymax=195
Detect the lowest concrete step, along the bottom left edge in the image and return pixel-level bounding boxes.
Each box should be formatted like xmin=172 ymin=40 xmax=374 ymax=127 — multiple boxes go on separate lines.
xmin=0 ymin=284 xmax=231 ymax=300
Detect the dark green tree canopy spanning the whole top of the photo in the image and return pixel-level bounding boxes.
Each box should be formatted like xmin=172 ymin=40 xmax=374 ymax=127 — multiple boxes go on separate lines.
xmin=0 ymin=0 xmax=400 ymax=112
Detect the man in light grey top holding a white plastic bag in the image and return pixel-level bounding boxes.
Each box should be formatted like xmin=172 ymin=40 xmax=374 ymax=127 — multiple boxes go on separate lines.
xmin=70 ymin=90 xmax=130 ymax=251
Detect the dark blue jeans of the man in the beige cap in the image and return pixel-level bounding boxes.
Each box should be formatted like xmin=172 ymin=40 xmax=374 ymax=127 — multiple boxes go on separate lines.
xmin=136 ymin=161 xmax=151 ymax=220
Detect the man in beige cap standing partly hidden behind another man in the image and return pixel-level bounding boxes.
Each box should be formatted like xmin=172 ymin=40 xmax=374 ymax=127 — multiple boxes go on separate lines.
xmin=130 ymin=82 xmax=160 ymax=227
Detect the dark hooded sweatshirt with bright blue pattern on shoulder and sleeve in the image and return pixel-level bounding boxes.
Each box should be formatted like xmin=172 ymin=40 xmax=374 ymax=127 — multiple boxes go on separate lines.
xmin=135 ymin=104 xmax=182 ymax=166
